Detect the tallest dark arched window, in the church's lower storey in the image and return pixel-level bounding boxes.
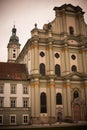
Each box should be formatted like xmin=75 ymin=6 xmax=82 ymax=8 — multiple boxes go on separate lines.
xmin=40 ymin=92 xmax=47 ymax=113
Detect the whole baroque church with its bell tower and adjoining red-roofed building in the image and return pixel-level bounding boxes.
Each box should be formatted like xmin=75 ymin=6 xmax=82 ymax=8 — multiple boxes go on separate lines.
xmin=0 ymin=4 xmax=87 ymax=125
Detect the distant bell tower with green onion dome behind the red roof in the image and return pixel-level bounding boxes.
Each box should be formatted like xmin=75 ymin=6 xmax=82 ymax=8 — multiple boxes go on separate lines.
xmin=7 ymin=25 xmax=20 ymax=62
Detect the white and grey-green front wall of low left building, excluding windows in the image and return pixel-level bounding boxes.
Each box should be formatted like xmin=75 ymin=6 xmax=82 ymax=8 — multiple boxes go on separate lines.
xmin=0 ymin=80 xmax=31 ymax=125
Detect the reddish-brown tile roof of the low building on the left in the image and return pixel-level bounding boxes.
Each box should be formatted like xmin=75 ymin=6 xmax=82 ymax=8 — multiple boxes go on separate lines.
xmin=0 ymin=62 xmax=28 ymax=80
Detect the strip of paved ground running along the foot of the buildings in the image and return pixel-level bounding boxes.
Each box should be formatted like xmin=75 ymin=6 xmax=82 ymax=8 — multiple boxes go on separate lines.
xmin=0 ymin=121 xmax=87 ymax=129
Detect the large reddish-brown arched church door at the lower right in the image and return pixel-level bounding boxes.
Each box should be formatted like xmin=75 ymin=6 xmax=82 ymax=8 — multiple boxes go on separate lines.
xmin=73 ymin=104 xmax=81 ymax=121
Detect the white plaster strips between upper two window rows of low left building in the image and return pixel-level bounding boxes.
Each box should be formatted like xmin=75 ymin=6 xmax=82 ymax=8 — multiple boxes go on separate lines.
xmin=3 ymin=83 xmax=31 ymax=107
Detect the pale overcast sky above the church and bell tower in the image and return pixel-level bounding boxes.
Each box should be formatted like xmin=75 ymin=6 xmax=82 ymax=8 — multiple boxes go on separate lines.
xmin=0 ymin=0 xmax=87 ymax=62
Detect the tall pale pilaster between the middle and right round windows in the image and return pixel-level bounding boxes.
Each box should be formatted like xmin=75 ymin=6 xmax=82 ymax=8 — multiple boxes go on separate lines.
xmin=65 ymin=44 xmax=70 ymax=74
